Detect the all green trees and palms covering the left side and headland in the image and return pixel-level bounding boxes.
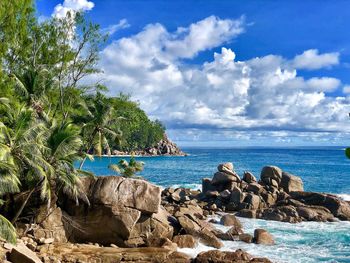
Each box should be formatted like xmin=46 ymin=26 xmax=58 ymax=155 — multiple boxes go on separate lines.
xmin=0 ymin=0 xmax=164 ymax=242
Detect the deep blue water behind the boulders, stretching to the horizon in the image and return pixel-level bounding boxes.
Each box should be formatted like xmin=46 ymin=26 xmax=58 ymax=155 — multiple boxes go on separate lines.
xmin=84 ymin=147 xmax=350 ymax=194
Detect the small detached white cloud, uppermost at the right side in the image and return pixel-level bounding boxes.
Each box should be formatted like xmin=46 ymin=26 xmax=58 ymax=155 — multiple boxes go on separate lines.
xmin=293 ymin=49 xmax=339 ymax=70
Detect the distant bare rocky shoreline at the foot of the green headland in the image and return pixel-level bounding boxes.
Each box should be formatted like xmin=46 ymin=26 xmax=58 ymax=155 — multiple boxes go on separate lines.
xmin=112 ymin=134 xmax=187 ymax=156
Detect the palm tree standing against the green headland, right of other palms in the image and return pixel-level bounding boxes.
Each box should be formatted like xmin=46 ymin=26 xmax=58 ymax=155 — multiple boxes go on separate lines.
xmin=80 ymin=92 xmax=121 ymax=169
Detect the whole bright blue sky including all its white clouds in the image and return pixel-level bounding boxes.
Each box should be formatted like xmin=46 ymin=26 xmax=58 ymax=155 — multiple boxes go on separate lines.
xmin=36 ymin=0 xmax=350 ymax=147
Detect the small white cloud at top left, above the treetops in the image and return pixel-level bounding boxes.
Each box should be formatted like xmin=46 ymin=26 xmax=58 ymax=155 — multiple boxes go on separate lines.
xmin=52 ymin=0 xmax=95 ymax=18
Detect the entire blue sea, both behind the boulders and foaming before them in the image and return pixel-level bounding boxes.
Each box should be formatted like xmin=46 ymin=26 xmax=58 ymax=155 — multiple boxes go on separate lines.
xmin=80 ymin=147 xmax=350 ymax=263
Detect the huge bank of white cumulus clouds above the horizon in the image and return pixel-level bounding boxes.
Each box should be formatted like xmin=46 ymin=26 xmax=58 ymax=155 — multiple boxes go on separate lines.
xmin=85 ymin=16 xmax=350 ymax=143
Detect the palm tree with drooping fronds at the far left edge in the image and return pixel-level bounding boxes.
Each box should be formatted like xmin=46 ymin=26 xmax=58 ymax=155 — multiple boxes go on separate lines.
xmin=0 ymin=104 xmax=54 ymax=222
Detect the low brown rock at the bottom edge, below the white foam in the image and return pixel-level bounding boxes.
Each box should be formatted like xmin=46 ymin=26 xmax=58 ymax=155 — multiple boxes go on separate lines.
xmin=194 ymin=252 xmax=271 ymax=263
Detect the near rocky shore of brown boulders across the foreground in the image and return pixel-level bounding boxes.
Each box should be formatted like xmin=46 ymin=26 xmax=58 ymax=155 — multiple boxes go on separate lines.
xmin=0 ymin=163 xmax=350 ymax=263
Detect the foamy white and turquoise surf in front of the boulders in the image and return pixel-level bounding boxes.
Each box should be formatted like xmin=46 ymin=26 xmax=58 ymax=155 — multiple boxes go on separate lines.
xmin=179 ymin=216 xmax=350 ymax=263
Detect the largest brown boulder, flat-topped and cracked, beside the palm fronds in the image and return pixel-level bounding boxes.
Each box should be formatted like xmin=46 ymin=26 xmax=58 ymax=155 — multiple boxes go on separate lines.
xmin=61 ymin=176 xmax=173 ymax=247
